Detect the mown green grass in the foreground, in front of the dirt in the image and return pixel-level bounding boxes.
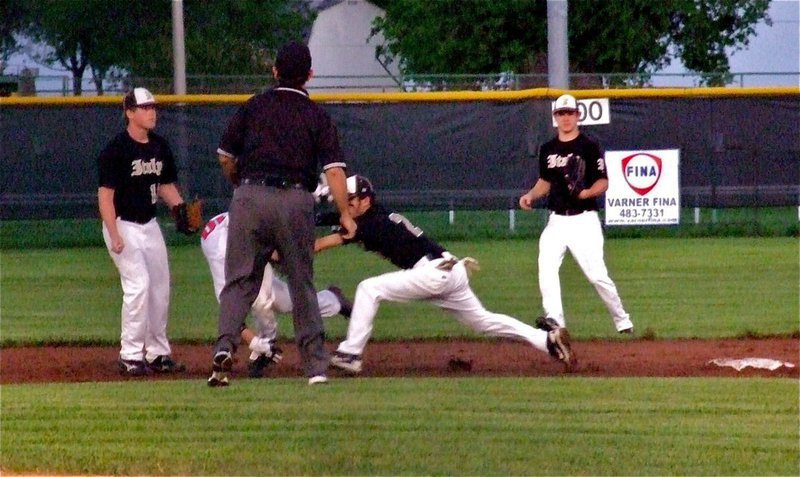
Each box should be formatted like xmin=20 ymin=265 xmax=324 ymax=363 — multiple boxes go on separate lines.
xmin=0 ymin=378 xmax=800 ymax=475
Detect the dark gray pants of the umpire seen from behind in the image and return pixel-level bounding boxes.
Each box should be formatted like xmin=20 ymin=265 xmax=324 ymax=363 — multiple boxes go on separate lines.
xmin=214 ymin=185 xmax=328 ymax=376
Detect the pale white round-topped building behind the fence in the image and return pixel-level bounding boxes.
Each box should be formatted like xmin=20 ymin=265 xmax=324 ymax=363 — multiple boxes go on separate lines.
xmin=308 ymin=0 xmax=400 ymax=92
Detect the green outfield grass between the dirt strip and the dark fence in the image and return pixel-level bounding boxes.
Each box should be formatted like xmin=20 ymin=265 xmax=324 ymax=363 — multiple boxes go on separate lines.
xmin=0 ymin=238 xmax=800 ymax=346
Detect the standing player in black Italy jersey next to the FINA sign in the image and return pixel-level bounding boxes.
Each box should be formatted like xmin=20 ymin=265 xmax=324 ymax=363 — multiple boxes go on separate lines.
xmin=519 ymin=94 xmax=633 ymax=333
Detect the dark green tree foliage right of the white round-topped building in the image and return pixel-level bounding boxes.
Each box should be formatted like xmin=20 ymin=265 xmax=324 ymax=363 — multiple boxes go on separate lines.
xmin=373 ymin=0 xmax=771 ymax=82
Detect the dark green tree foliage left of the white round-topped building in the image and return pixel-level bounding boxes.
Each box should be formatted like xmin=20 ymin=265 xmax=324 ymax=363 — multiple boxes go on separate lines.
xmin=15 ymin=0 xmax=314 ymax=95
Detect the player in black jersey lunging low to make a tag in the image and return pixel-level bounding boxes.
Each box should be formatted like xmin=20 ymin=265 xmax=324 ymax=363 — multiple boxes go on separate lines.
xmin=315 ymin=176 xmax=575 ymax=373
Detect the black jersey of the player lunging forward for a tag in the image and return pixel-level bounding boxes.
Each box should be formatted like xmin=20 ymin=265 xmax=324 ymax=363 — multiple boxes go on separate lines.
xmin=345 ymin=204 xmax=445 ymax=269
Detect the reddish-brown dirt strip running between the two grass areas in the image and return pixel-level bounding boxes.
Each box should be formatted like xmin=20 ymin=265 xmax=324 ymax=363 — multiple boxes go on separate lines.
xmin=0 ymin=338 xmax=800 ymax=384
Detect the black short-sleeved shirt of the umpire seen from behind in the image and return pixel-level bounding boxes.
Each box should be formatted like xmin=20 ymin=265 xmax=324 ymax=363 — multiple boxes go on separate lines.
xmin=217 ymin=86 xmax=345 ymax=191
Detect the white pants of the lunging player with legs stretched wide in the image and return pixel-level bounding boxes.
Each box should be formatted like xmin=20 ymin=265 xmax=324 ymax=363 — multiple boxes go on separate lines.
xmin=338 ymin=258 xmax=547 ymax=355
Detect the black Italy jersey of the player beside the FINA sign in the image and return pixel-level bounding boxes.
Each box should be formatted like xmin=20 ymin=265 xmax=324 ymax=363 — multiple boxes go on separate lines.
xmin=539 ymin=133 xmax=608 ymax=213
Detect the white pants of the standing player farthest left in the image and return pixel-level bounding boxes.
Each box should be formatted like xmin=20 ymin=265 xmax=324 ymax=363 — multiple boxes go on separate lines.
xmin=103 ymin=218 xmax=171 ymax=361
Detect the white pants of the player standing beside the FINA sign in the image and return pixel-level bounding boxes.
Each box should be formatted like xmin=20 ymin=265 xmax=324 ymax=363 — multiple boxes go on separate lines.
xmin=539 ymin=211 xmax=633 ymax=331
